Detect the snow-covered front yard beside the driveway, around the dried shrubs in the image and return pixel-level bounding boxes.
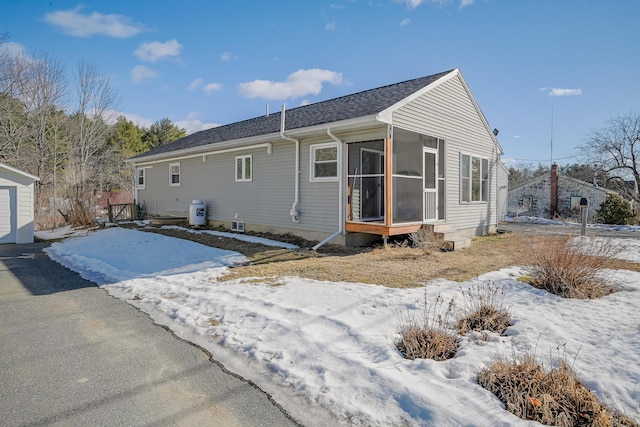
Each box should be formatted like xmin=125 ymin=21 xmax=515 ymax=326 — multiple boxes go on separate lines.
xmin=46 ymin=228 xmax=640 ymax=426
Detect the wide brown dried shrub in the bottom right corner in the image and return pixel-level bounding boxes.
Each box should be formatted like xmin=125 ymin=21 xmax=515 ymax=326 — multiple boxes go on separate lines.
xmin=477 ymin=355 xmax=638 ymax=427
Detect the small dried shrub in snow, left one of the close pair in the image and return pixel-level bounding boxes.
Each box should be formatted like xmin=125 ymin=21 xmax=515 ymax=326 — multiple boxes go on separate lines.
xmin=395 ymin=290 xmax=458 ymax=361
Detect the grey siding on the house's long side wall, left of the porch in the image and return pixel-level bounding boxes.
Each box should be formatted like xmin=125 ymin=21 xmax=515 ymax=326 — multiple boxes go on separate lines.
xmin=138 ymin=141 xmax=338 ymax=233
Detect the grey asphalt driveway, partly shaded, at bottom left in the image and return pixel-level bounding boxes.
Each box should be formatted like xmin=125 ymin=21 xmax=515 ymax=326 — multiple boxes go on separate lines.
xmin=0 ymin=243 xmax=298 ymax=426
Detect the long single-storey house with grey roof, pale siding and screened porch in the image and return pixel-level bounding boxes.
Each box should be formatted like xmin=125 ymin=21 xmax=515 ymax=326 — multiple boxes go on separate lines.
xmin=128 ymin=69 xmax=506 ymax=248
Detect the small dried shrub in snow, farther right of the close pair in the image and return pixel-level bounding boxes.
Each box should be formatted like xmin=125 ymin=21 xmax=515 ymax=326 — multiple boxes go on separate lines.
xmin=456 ymin=282 xmax=512 ymax=338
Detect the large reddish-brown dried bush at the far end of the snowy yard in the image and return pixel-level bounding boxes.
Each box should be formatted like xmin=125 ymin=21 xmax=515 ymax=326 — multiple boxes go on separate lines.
xmin=527 ymin=238 xmax=621 ymax=299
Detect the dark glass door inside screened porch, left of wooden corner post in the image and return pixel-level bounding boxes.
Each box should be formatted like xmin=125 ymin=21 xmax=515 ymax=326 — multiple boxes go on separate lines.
xmin=360 ymin=148 xmax=384 ymax=221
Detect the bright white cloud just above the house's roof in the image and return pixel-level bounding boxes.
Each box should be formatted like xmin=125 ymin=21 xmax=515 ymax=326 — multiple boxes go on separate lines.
xmin=238 ymin=68 xmax=342 ymax=100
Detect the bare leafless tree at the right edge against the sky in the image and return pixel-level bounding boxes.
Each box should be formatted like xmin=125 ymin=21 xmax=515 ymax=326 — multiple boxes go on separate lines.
xmin=581 ymin=113 xmax=640 ymax=202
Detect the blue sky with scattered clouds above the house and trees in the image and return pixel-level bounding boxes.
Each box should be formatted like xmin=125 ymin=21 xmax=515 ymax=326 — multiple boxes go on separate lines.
xmin=0 ymin=0 xmax=640 ymax=165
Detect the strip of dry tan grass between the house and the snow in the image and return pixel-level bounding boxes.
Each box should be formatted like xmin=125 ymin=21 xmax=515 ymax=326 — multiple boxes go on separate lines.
xmin=136 ymin=228 xmax=640 ymax=288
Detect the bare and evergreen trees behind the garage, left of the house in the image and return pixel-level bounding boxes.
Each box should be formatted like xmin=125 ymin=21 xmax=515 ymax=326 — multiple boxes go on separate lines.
xmin=0 ymin=34 xmax=186 ymax=228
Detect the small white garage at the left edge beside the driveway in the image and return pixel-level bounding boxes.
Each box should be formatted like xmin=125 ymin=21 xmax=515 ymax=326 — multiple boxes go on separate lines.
xmin=0 ymin=163 xmax=40 ymax=243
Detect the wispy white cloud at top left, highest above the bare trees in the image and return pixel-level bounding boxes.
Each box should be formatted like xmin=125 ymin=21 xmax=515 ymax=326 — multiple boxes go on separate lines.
xmin=45 ymin=6 xmax=143 ymax=39
